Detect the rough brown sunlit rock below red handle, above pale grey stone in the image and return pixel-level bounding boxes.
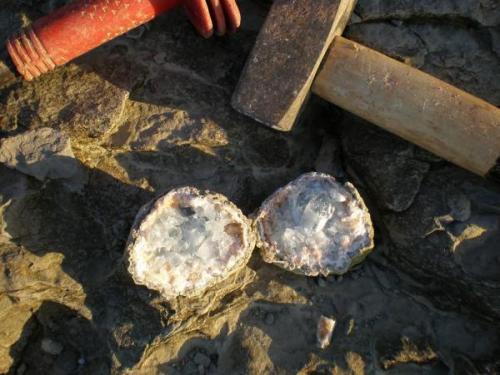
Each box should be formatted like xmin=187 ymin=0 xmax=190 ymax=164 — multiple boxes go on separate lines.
xmin=0 ymin=61 xmax=129 ymax=138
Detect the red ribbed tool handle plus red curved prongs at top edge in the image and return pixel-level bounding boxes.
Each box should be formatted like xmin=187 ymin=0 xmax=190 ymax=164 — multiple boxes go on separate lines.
xmin=0 ymin=0 xmax=240 ymax=88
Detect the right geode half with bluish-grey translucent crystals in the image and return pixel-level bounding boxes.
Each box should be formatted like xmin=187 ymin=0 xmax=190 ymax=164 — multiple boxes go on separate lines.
xmin=254 ymin=173 xmax=373 ymax=276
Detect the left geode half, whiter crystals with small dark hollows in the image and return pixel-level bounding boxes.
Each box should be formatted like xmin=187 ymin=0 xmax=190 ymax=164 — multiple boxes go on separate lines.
xmin=126 ymin=187 xmax=255 ymax=298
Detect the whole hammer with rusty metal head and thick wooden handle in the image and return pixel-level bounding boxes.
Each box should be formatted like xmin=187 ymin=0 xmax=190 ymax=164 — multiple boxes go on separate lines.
xmin=232 ymin=0 xmax=500 ymax=176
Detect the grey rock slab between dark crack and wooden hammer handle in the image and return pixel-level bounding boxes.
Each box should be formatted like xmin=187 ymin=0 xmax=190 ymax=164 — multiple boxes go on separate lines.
xmin=346 ymin=22 xmax=500 ymax=105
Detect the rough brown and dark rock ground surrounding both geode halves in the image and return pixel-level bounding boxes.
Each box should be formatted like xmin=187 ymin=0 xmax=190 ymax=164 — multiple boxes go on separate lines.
xmin=0 ymin=0 xmax=500 ymax=375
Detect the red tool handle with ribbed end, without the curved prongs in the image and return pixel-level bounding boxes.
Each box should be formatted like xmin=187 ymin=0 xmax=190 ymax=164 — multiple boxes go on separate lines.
xmin=7 ymin=0 xmax=183 ymax=80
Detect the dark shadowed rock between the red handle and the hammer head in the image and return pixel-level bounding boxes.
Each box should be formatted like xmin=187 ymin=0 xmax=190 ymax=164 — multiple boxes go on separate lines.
xmin=76 ymin=5 xmax=257 ymax=106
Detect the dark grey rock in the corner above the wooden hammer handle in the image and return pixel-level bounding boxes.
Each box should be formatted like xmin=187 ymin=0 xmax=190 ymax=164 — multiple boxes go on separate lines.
xmin=346 ymin=0 xmax=500 ymax=105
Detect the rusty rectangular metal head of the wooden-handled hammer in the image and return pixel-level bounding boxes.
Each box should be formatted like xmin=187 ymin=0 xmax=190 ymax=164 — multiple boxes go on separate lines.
xmin=232 ymin=0 xmax=356 ymax=131
